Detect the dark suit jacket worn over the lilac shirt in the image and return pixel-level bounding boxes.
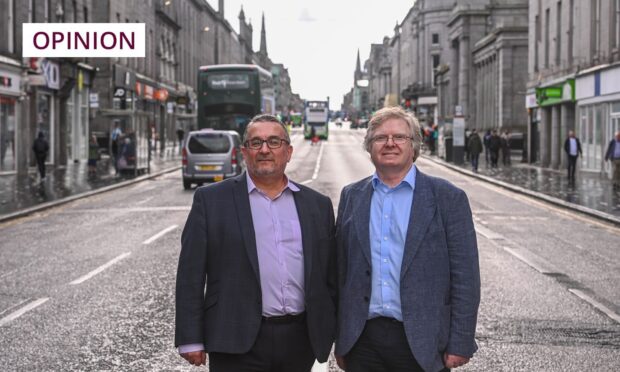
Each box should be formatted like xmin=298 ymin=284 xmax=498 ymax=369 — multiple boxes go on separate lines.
xmin=175 ymin=173 xmax=337 ymax=362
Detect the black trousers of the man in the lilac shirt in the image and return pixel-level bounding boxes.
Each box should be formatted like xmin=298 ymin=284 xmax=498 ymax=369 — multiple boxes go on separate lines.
xmin=209 ymin=316 xmax=315 ymax=372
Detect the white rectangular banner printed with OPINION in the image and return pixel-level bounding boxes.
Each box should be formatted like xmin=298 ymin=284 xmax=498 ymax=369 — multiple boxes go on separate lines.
xmin=22 ymin=23 xmax=146 ymax=58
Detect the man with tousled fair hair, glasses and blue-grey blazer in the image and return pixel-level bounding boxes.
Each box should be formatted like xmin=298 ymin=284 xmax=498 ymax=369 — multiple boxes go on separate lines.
xmin=335 ymin=107 xmax=480 ymax=372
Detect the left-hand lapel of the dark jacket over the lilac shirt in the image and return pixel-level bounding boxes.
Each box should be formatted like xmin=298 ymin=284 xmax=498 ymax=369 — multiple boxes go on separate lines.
xmin=233 ymin=173 xmax=260 ymax=285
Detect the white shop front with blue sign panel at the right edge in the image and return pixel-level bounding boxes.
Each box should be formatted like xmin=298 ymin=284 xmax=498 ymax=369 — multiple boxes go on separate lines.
xmin=576 ymin=66 xmax=620 ymax=178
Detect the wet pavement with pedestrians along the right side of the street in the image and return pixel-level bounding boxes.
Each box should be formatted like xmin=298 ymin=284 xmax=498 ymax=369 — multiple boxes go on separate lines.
xmin=422 ymin=153 xmax=620 ymax=225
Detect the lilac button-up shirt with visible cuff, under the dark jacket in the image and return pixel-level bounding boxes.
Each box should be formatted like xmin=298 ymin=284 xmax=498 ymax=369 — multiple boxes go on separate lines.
xmin=179 ymin=175 xmax=305 ymax=353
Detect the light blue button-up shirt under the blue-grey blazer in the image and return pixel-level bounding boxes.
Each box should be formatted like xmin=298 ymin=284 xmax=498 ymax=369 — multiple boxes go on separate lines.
xmin=368 ymin=165 xmax=416 ymax=321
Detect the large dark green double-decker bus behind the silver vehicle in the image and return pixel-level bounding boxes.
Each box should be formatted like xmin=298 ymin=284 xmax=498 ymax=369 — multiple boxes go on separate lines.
xmin=198 ymin=64 xmax=275 ymax=135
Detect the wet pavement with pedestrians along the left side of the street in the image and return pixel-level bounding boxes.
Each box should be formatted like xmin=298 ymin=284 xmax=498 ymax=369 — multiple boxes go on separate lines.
xmin=0 ymin=147 xmax=181 ymax=222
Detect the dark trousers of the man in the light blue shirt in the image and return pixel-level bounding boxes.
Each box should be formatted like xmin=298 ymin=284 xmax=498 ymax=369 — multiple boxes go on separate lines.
xmin=345 ymin=317 xmax=449 ymax=372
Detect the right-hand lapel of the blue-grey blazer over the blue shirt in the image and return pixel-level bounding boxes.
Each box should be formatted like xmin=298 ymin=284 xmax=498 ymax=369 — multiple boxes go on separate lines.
xmin=400 ymin=170 xmax=435 ymax=280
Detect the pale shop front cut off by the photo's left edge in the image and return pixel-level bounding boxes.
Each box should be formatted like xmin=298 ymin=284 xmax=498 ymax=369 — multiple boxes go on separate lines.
xmin=0 ymin=65 xmax=21 ymax=173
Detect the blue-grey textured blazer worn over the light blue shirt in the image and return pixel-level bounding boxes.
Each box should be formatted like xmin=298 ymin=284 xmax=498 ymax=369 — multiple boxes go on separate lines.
xmin=336 ymin=170 xmax=480 ymax=371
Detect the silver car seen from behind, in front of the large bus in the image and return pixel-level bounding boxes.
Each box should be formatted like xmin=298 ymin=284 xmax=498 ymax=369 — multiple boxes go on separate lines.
xmin=182 ymin=129 xmax=245 ymax=190
